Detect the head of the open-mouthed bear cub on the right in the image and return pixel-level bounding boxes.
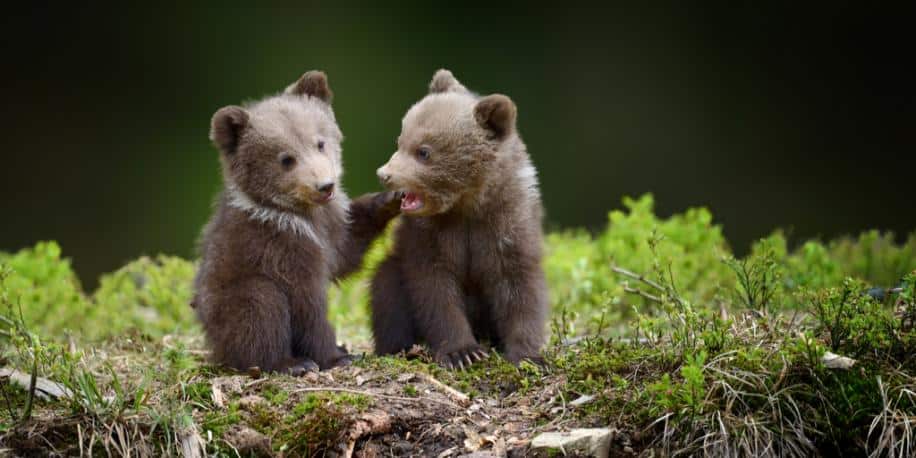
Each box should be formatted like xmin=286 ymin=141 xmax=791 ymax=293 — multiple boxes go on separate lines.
xmin=378 ymin=70 xmax=519 ymax=216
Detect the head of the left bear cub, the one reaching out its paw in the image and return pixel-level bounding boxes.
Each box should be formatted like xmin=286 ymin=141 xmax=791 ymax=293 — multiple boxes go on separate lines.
xmin=210 ymin=71 xmax=343 ymax=213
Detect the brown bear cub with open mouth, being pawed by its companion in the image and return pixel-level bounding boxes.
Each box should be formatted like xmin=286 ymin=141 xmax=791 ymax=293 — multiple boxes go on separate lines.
xmin=371 ymin=70 xmax=548 ymax=368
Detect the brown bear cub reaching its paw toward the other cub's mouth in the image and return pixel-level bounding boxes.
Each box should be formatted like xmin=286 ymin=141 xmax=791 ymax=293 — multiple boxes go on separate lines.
xmin=193 ymin=71 xmax=398 ymax=374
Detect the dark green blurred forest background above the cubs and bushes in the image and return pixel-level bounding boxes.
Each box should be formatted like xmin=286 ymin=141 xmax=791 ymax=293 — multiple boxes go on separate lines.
xmin=0 ymin=2 xmax=916 ymax=289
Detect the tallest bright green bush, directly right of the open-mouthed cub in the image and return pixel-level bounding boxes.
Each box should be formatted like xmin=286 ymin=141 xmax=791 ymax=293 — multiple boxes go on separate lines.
xmin=544 ymin=194 xmax=734 ymax=333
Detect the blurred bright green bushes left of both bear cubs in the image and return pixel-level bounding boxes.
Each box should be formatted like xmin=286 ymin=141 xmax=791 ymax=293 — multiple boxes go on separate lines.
xmin=0 ymin=242 xmax=194 ymax=339
